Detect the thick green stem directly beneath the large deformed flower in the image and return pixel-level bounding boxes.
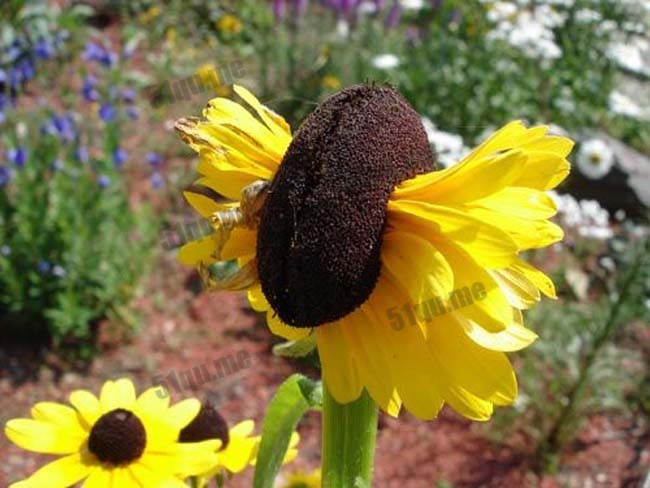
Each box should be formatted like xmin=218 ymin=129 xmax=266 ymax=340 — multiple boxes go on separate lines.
xmin=322 ymin=382 xmax=378 ymax=488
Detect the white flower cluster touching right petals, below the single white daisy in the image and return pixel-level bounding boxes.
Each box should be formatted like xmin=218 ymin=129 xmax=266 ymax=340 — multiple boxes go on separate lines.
xmin=548 ymin=191 xmax=614 ymax=240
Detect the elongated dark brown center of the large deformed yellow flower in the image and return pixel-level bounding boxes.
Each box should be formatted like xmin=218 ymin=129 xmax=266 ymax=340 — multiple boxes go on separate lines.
xmin=257 ymin=85 xmax=434 ymax=327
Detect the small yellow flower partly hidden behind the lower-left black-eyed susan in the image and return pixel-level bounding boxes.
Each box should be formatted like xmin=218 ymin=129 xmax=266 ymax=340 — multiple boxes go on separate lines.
xmin=179 ymin=402 xmax=299 ymax=487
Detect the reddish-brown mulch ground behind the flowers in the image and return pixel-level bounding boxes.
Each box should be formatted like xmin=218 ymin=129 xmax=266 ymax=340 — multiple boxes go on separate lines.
xmin=0 ymin=254 xmax=650 ymax=488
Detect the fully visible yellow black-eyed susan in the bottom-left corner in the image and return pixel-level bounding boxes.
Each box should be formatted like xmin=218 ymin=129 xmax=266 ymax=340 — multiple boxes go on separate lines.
xmin=5 ymin=379 xmax=220 ymax=488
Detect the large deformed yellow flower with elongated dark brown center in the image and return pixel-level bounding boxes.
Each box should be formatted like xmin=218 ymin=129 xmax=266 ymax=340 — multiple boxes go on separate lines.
xmin=177 ymin=85 xmax=573 ymax=420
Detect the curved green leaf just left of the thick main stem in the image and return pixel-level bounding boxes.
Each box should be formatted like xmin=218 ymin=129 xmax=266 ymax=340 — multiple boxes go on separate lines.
xmin=253 ymin=374 xmax=323 ymax=488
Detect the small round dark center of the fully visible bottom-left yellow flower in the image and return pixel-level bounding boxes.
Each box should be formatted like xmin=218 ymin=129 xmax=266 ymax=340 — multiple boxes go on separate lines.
xmin=88 ymin=408 xmax=147 ymax=465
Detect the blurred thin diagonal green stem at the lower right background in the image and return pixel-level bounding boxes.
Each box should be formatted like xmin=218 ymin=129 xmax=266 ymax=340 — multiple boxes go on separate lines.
xmin=535 ymin=239 xmax=650 ymax=471
